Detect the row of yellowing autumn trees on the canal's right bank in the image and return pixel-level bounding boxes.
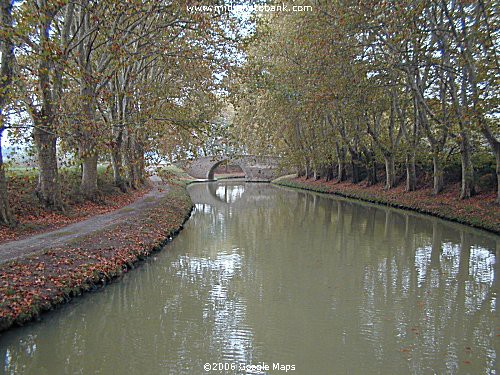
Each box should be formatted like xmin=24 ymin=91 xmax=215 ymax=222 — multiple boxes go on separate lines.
xmin=235 ymin=0 xmax=500 ymax=202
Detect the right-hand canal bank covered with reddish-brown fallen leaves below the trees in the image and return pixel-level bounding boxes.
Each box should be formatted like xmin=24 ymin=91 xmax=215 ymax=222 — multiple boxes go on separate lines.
xmin=274 ymin=177 xmax=500 ymax=234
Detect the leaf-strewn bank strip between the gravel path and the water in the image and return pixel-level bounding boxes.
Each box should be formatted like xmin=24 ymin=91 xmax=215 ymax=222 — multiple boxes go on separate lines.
xmin=0 ymin=184 xmax=194 ymax=333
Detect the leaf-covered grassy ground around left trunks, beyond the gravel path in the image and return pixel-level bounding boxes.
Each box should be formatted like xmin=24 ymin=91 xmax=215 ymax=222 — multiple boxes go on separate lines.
xmin=0 ymin=166 xmax=150 ymax=243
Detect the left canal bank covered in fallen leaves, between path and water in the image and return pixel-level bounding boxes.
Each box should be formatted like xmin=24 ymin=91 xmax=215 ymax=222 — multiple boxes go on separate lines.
xmin=0 ymin=184 xmax=192 ymax=331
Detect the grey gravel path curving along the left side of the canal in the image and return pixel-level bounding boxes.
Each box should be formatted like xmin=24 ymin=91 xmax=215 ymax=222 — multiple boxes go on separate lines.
xmin=0 ymin=176 xmax=168 ymax=264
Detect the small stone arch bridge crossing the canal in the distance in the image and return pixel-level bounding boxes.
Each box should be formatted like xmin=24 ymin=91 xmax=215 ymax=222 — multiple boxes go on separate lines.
xmin=176 ymin=155 xmax=282 ymax=181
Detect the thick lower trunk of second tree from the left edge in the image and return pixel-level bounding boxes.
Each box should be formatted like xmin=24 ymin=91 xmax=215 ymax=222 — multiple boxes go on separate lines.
xmin=33 ymin=124 xmax=64 ymax=211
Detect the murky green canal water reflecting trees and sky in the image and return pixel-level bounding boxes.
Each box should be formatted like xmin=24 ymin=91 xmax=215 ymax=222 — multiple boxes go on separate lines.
xmin=0 ymin=181 xmax=500 ymax=375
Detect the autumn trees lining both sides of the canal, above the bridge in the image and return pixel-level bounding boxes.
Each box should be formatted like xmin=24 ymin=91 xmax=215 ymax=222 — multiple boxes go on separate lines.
xmin=0 ymin=0 xmax=500 ymax=224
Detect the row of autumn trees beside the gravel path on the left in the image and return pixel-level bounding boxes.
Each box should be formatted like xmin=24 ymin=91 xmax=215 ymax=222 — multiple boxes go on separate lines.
xmin=0 ymin=0 xmax=236 ymax=224
